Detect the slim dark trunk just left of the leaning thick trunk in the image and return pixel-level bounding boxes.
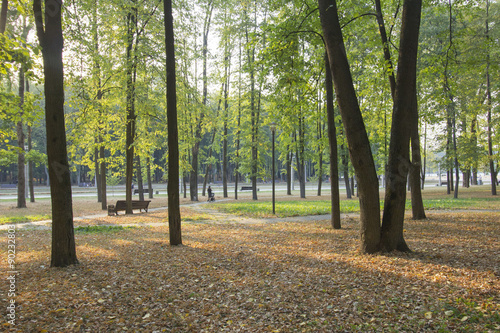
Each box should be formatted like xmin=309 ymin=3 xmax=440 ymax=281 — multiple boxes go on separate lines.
xmin=325 ymin=53 xmax=341 ymax=229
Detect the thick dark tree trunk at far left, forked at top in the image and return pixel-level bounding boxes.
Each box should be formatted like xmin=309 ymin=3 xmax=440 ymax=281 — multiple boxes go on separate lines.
xmin=33 ymin=0 xmax=78 ymax=267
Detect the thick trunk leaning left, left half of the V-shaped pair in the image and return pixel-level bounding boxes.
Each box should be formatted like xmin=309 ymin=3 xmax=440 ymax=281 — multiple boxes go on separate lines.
xmin=318 ymin=0 xmax=380 ymax=253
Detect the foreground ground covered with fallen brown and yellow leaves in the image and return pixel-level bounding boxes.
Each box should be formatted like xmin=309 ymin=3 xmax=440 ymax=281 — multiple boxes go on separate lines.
xmin=0 ymin=208 xmax=500 ymax=332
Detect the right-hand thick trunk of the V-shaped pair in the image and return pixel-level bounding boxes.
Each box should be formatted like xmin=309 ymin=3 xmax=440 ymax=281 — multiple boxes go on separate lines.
xmin=380 ymin=0 xmax=422 ymax=251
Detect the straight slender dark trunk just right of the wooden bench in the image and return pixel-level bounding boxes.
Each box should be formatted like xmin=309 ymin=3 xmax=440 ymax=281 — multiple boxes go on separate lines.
xmin=163 ymin=0 xmax=182 ymax=245
